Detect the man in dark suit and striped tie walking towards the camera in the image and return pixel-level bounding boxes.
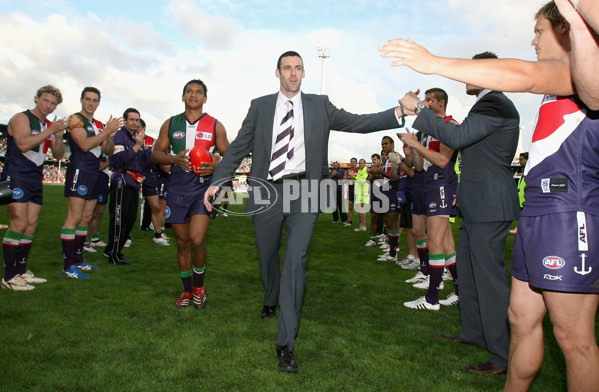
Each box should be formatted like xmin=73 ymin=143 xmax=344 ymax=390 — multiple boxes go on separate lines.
xmin=204 ymin=51 xmax=399 ymax=372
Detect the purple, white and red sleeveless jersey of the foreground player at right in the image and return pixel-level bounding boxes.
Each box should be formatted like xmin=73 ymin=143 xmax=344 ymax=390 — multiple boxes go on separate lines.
xmin=522 ymin=95 xmax=599 ymax=216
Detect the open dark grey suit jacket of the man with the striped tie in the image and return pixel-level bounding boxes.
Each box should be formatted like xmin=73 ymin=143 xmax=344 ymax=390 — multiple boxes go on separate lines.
xmin=212 ymin=93 xmax=399 ymax=207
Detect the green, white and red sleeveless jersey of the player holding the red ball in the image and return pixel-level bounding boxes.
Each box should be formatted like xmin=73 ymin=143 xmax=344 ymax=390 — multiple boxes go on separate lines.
xmin=168 ymin=113 xmax=217 ymax=194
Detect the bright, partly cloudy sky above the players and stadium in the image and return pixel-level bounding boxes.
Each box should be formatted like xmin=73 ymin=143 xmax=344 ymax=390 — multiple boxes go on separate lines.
xmin=0 ymin=0 xmax=547 ymax=162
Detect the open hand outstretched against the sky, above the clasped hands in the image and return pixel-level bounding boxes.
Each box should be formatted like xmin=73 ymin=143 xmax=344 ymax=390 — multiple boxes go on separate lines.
xmin=379 ymin=38 xmax=439 ymax=75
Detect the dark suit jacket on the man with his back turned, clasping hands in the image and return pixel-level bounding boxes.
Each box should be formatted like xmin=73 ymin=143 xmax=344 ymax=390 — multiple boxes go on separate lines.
xmin=414 ymin=91 xmax=520 ymax=222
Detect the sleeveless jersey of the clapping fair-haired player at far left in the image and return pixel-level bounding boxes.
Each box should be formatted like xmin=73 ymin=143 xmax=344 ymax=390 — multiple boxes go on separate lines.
xmin=2 ymin=110 xmax=54 ymax=182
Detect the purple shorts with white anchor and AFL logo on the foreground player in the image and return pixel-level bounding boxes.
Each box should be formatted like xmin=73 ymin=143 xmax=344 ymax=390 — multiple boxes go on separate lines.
xmin=511 ymin=212 xmax=599 ymax=294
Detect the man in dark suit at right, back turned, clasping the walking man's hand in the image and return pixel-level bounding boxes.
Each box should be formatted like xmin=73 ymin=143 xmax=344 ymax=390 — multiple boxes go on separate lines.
xmin=400 ymin=52 xmax=520 ymax=374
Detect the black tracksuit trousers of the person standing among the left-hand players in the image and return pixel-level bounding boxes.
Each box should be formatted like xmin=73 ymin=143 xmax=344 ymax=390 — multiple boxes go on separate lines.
xmin=105 ymin=173 xmax=139 ymax=256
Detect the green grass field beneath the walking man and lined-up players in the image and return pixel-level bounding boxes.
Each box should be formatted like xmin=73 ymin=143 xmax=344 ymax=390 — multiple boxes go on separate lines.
xmin=0 ymin=186 xmax=596 ymax=392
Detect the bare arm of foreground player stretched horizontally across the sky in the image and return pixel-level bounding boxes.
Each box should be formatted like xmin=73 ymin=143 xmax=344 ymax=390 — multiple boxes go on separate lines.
xmin=379 ymin=38 xmax=574 ymax=96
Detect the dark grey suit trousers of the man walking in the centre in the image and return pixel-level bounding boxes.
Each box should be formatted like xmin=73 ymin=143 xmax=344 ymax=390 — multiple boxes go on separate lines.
xmin=253 ymin=184 xmax=318 ymax=350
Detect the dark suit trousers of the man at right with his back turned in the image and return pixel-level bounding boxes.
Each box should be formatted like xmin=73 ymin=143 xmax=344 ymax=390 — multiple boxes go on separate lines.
xmin=457 ymin=220 xmax=511 ymax=369
